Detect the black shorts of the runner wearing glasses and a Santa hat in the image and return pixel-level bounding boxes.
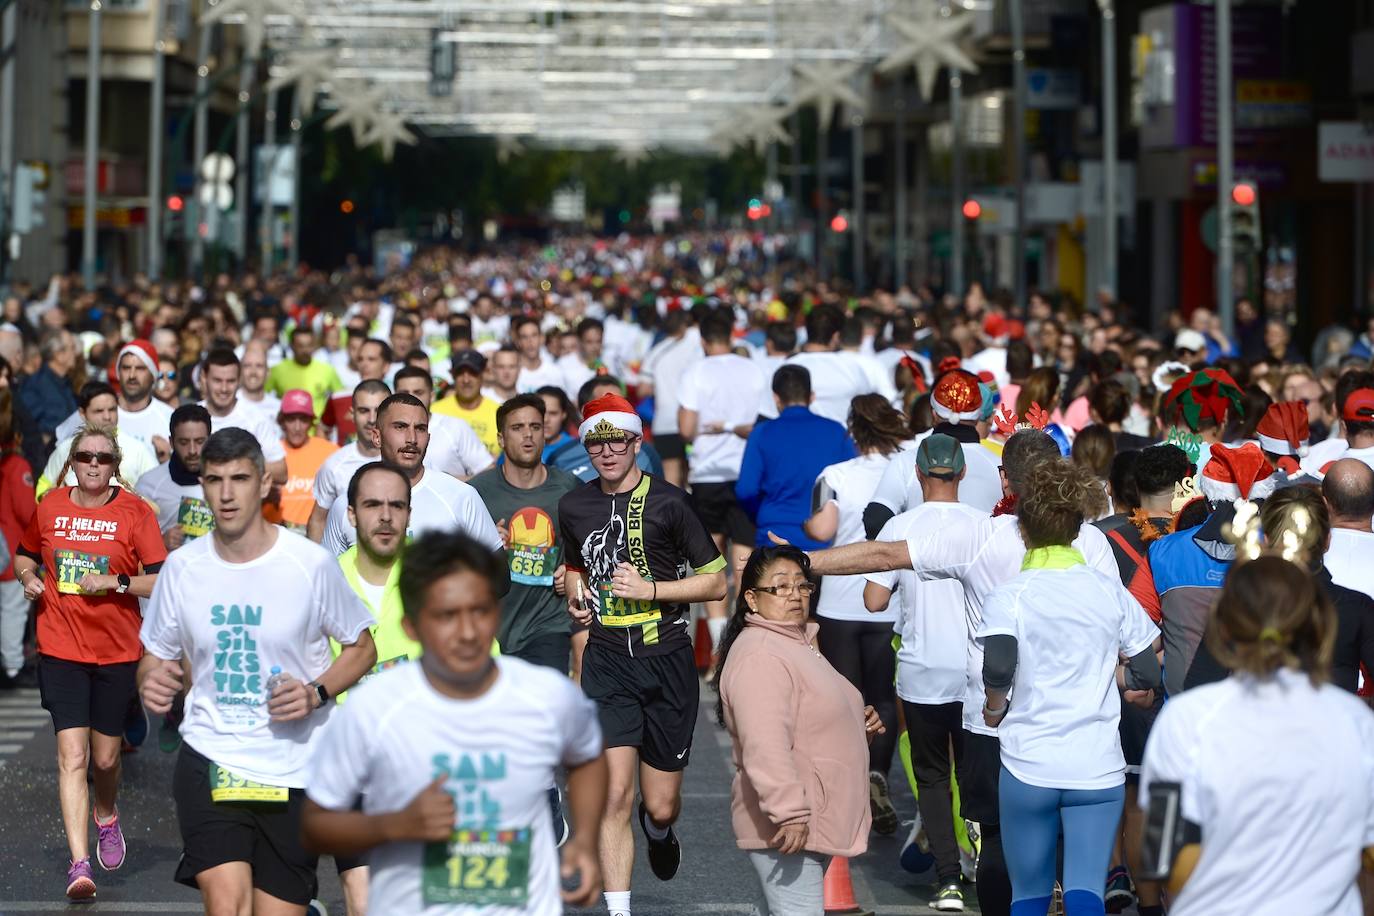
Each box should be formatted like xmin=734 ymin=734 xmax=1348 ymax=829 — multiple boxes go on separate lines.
xmin=583 ymin=640 xmax=701 ymax=773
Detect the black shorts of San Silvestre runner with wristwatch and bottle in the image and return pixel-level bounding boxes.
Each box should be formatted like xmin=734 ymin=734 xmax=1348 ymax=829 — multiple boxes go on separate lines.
xmin=172 ymin=742 xmax=319 ymax=906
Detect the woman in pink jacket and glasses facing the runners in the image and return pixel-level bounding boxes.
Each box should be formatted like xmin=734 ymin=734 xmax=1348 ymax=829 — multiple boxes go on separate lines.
xmin=716 ymin=547 xmax=883 ymax=916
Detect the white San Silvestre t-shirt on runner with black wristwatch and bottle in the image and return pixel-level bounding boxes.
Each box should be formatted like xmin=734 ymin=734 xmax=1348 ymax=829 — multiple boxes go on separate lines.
xmin=139 ymin=527 xmax=375 ymax=788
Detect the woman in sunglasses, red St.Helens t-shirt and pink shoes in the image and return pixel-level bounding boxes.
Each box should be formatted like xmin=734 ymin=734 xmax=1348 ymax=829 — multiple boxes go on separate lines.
xmin=14 ymin=426 xmax=166 ymax=900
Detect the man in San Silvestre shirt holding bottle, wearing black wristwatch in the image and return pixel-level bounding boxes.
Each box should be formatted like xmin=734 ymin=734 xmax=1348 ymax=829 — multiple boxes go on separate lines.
xmin=139 ymin=427 xmax=376 ymax=913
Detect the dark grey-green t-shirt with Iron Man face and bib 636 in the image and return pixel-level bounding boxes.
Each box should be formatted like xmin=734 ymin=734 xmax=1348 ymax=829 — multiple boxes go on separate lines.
xmin=469 ymin=466 xmax=581 ymax=655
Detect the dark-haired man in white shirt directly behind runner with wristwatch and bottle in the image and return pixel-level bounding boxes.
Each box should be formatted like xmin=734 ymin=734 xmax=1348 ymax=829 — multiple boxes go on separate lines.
xmin=133 ymin=404 xmax=214 ymax=551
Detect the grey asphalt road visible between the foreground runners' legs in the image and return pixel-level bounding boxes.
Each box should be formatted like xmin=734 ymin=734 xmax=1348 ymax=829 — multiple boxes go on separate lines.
xmin=0 ymin=688 xmax=977 ymax=916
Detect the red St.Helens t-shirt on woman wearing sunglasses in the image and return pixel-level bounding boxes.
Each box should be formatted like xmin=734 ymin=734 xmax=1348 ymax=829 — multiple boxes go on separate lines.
xmin=19 ymin=486 xmax=168 ymax=665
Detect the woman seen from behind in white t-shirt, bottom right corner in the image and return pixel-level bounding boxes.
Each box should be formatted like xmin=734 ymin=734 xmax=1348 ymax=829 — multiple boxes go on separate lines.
xmin=1140 ymin=547 xmax=1374 ymax=916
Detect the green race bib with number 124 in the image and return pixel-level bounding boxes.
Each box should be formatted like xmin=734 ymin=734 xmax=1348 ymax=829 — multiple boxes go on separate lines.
xmin=420 ymin=827 xmax=532 ymax=906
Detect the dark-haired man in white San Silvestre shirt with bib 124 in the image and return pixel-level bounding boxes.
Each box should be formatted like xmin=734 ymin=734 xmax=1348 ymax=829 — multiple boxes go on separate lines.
xmin=302 ymin=530 xmax=606 ymax=916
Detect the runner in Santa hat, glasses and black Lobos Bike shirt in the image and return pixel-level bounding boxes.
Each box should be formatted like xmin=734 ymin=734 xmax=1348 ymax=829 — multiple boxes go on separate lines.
xmin=558 ymin=394 xmax=725 ymax=916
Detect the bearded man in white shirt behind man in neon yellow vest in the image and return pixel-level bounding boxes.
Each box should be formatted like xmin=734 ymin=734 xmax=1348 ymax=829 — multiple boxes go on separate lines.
xmin=322 ymin=394 xmax=510 ymax=579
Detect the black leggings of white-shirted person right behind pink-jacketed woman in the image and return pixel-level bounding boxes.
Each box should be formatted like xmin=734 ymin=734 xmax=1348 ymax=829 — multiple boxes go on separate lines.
xmin=818 ymin=617 xmax=897 ymax=776
